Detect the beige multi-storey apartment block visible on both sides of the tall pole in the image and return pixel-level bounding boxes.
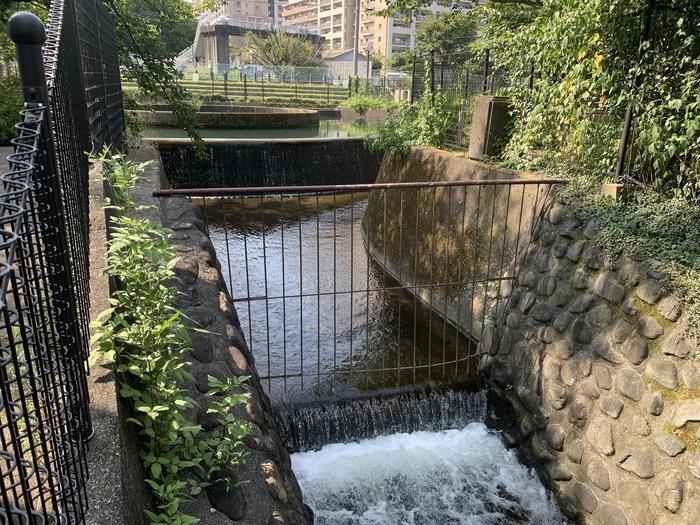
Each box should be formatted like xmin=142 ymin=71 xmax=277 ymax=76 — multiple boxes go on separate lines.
xmin=282 ymin=0 xmax=469 ymax=58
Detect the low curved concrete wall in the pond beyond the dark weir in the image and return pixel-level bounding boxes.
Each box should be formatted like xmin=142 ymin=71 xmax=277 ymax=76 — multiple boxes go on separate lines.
xmin=131 ymin=104 xmax=319 ymax=129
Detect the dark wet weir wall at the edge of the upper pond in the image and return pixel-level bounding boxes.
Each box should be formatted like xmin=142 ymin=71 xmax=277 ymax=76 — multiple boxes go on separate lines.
xmin=152 ymin=138 xmax=383 ymax=188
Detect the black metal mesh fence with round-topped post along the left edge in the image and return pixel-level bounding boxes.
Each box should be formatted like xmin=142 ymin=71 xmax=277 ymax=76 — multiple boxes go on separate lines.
xmin=0 ymin=0 xmax=123 ymax=524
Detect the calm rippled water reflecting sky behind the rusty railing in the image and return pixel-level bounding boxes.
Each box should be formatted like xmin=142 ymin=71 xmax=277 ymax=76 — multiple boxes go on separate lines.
xmin=206 ymin=194 xmax=474 ymax=402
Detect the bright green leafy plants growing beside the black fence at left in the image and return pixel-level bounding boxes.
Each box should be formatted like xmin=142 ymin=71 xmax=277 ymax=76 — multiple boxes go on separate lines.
xmin=92 ymin=150 xmax=249 ymax=525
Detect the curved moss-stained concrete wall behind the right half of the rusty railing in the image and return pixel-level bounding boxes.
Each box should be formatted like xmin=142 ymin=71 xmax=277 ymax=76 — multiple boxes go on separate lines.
xmin=362 ymin=147 xmax=550 ymax=340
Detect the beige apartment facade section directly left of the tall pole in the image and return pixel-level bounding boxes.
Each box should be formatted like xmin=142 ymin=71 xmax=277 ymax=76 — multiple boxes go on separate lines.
xmin=282 ymin=0 xmax=355 ymax=50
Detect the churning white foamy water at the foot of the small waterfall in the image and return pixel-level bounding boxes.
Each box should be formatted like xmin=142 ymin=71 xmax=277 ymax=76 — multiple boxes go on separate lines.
xmin=292 ymin=423 xmax=568 ymax=525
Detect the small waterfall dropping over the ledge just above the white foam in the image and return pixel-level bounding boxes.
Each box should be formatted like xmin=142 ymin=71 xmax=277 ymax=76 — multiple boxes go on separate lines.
xmin=275 ymin=391 xmax=487 ymax=452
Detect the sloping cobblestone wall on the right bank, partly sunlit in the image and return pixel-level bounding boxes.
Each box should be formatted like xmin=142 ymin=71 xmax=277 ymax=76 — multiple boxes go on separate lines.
xmin=480 ymin=200 xmax=700 ymax=525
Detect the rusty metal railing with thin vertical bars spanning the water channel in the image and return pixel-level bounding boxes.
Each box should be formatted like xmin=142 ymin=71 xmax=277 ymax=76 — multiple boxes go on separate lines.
xmin=155 ymin=180 xmax=564 ymax=401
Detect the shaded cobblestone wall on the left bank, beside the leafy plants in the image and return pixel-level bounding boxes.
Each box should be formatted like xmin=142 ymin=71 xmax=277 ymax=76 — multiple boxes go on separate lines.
xmin=161 ymin=194 xmax=312 ymax=525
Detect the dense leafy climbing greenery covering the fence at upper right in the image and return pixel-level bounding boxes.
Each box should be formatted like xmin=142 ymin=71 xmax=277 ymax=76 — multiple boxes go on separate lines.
xmin=474 ymin=0 xmax=700 ymax=201
